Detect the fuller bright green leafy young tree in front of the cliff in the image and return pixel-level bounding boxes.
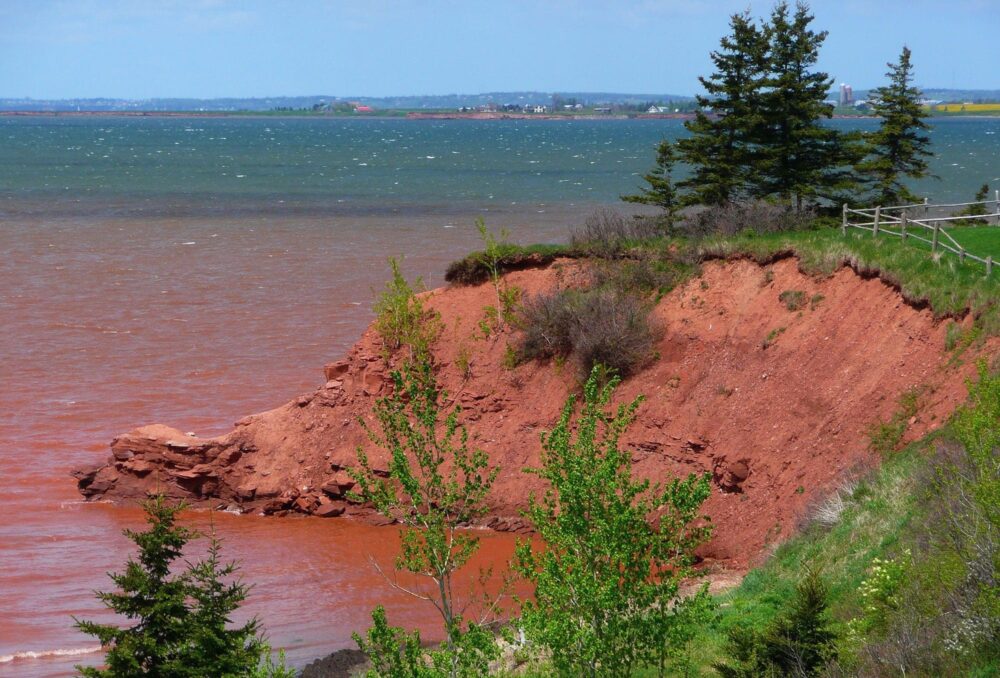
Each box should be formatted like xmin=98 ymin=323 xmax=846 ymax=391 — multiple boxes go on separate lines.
xmin=516 ymin=367 xmax=710 ymax=676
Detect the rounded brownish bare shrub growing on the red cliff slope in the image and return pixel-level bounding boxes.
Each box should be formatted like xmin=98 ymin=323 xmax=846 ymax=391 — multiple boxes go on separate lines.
xmin=516 ymin=289 xmax=659 ymax=377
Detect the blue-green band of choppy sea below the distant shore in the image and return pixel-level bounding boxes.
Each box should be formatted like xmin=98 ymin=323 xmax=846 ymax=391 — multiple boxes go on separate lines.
xmin=0 ymin=118 xmax=1000 ymax=216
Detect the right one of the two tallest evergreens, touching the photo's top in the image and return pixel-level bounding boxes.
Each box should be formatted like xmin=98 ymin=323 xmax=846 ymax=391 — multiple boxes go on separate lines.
xmin=750 ymin=2 xmax=852 ymax=209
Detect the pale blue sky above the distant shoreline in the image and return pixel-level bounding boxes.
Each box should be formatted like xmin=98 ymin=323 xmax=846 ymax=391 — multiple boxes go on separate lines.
xmin=0 ymin=0 xmax=1000 ymax=99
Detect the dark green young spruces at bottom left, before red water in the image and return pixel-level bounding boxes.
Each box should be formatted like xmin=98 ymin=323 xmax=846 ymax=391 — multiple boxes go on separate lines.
xmin=76 ymin=495 xmax=292 ymax=678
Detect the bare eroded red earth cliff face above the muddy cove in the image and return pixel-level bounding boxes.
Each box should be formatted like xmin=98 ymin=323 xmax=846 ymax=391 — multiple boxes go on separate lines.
xmin=75 ymin=259 xmax=998 ymax=568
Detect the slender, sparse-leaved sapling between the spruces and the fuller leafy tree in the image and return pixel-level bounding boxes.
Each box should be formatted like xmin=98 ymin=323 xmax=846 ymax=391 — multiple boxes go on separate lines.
xmin=351 ymin=360 xmax=499 ymax=676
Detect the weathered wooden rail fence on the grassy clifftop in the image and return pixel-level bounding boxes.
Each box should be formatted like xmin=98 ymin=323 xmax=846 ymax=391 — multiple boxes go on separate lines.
xmin=842 ymin=191 xmax=1000 ymax=276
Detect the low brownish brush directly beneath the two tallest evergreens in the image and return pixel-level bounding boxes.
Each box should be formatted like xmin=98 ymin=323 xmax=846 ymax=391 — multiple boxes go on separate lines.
xmin=678 ymin=201 xmax=816 ymax=237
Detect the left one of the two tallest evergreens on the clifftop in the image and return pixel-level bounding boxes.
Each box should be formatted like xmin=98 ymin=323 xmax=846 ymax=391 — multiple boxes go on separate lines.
xmin=677 ymin=12 xmax=767 ymax=205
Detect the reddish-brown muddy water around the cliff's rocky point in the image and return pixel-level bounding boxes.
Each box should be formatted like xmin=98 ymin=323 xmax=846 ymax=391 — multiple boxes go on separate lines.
xmin=0 ymin=206 xmax=587 ymax=676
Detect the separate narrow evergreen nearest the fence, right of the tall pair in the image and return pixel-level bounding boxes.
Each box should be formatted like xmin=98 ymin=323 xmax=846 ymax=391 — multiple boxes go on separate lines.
xmin=858 ymin=46 xmax=933 ymax=205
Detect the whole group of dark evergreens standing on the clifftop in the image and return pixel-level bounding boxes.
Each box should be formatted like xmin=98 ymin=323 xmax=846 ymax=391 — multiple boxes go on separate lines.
xmin=623 ymin=2 xmax=931 ymax=215
